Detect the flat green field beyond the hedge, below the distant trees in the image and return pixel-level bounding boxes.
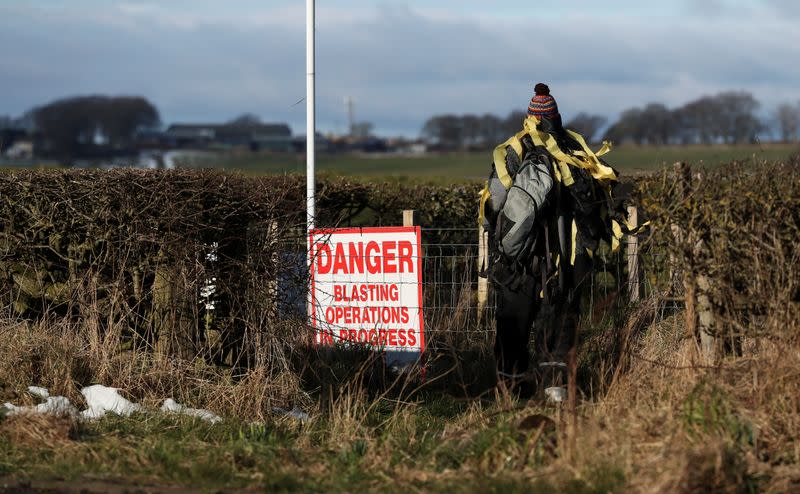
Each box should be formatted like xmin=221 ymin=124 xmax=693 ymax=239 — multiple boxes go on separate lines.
xmin=209 ymin=144 xmax=800 ymax=180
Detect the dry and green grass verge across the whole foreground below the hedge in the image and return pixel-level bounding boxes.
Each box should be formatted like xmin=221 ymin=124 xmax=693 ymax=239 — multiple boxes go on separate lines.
xmin=0 ymin=302 xmax=800 ymax=493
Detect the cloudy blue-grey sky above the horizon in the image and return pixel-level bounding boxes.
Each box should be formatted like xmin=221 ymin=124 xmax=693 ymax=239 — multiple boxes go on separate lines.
xmin=0 ymin=0 xmax=800 ymax=136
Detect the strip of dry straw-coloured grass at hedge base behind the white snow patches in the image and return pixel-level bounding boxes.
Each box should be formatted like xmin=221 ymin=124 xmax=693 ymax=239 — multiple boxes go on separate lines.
xmin=0 ymin=314 xmax=311 ymax=420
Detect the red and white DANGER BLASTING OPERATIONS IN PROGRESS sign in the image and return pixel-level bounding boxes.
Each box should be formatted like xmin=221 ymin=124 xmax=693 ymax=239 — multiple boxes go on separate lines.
xmin=309 ymin=226 xmax=425 ymax=352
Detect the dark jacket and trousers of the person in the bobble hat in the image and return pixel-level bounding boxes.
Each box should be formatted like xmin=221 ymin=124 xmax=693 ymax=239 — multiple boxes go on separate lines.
xmin=487 ymin=115 xmax=604 ymax=388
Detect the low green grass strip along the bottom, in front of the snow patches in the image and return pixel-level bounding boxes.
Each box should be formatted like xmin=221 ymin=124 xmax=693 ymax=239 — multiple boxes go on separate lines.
xmin=0 ymin=396 xmax=625 ymax=493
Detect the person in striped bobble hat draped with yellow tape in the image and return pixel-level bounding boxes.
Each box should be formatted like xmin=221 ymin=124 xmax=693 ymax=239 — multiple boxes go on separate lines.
xmin=482 ymin=83 xmax=600 ymax=401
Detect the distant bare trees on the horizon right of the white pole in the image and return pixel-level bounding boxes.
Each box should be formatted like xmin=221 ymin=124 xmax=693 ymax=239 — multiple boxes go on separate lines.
xmin=421 ymin=91 xmax=800 ymax=150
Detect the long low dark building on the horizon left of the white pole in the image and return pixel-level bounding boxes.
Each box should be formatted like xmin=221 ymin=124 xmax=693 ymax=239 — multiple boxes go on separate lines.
xmin=163 ymin=124 xmax=292 ymax=152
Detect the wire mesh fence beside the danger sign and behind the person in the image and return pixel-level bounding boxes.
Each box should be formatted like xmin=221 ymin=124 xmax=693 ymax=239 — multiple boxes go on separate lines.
xmin=278 ymin=218 xmax=682 ymax=349
